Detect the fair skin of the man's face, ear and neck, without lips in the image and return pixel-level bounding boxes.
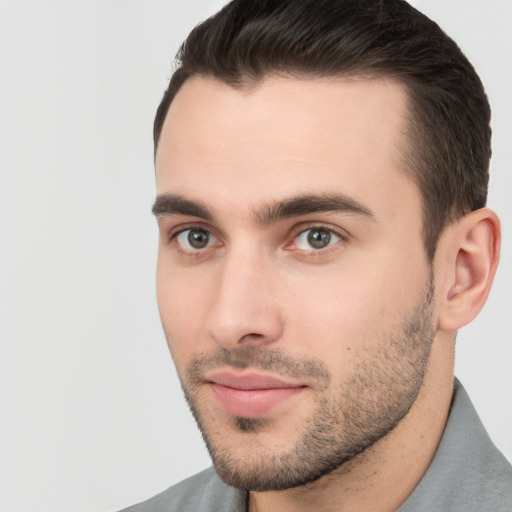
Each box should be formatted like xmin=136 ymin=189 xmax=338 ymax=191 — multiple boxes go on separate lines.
xmin=155 ymin=77 xmax=499 ymax=511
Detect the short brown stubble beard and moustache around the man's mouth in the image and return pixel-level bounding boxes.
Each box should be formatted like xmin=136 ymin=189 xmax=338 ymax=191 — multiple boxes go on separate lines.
xmin=175 ymin=279 xmax=434 ymax=492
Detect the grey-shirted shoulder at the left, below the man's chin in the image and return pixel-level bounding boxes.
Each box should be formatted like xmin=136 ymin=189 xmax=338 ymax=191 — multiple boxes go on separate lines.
xmin=121 ymin=468 xmax=246 ymax=512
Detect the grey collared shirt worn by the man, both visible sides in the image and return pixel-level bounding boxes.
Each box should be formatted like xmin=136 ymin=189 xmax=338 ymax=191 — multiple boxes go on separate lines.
xmin=122 ymin=381 xmax=512 ymax=512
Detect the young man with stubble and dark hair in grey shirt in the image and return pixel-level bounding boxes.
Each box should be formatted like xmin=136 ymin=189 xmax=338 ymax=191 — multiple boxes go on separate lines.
xmin=122 ymin=0 xmax=512 ymax=512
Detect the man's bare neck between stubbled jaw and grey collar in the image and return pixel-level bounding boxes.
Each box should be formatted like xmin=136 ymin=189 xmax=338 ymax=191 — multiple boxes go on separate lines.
xmin=249 ymin=339 xmax=454 ymax=512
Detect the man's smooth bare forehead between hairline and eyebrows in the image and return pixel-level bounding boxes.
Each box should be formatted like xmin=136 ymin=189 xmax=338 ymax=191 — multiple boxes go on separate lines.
xmin=156 ymin=77 xmax=417 ymax=222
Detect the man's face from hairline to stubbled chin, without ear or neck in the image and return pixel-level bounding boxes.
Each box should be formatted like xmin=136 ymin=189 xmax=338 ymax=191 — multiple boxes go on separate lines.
xmin=154 ymin=78 xmax=434 ymax=491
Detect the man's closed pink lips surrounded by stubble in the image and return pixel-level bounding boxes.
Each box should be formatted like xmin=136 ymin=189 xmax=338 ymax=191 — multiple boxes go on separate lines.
xmin=205 ymin=370 xmax=307 ymax=418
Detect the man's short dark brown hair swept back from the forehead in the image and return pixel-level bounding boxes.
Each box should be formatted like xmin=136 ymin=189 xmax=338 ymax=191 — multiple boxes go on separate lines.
xmin=154 ymin=0 xmax=491 ymax=261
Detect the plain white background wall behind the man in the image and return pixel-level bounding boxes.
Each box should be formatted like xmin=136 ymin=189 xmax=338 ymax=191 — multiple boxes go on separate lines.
xmin=0 ymin=0 xmax=512 ymax=512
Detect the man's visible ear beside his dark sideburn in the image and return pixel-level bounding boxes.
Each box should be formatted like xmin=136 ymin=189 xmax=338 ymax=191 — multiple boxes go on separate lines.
xmin=435 ymin=208 xmax=501 ymax=332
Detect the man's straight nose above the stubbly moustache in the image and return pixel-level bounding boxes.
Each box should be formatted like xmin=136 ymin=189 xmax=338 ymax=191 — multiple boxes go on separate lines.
xmin=206 ymin=254 xmax=283 ymax=350
